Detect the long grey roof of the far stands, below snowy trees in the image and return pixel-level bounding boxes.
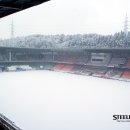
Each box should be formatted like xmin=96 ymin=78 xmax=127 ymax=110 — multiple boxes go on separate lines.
xmin=0 ymin=46 xmax=130 ymax=53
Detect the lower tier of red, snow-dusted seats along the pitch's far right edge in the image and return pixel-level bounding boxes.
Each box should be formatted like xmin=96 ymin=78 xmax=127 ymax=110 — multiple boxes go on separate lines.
xmin=37 ymin=63 xmax=130 ymax=79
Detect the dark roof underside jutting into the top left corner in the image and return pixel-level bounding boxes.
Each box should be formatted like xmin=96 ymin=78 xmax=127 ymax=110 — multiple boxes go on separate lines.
xmin=0 ymin=0 xmax=49 ymax=18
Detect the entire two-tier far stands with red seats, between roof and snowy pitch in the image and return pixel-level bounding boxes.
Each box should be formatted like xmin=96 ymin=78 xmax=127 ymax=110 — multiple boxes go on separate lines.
xmin=0 ymin=46 xmax=130 ymax=82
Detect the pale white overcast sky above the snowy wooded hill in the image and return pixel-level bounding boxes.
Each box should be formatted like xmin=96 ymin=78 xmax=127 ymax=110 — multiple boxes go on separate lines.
xmin=0 ymin=0 xmax=130 ymax=38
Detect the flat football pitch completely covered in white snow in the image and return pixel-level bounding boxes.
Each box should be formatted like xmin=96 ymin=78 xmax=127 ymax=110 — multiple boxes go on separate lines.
xmin=0 ymin=70 xmax=130 ymax=130
